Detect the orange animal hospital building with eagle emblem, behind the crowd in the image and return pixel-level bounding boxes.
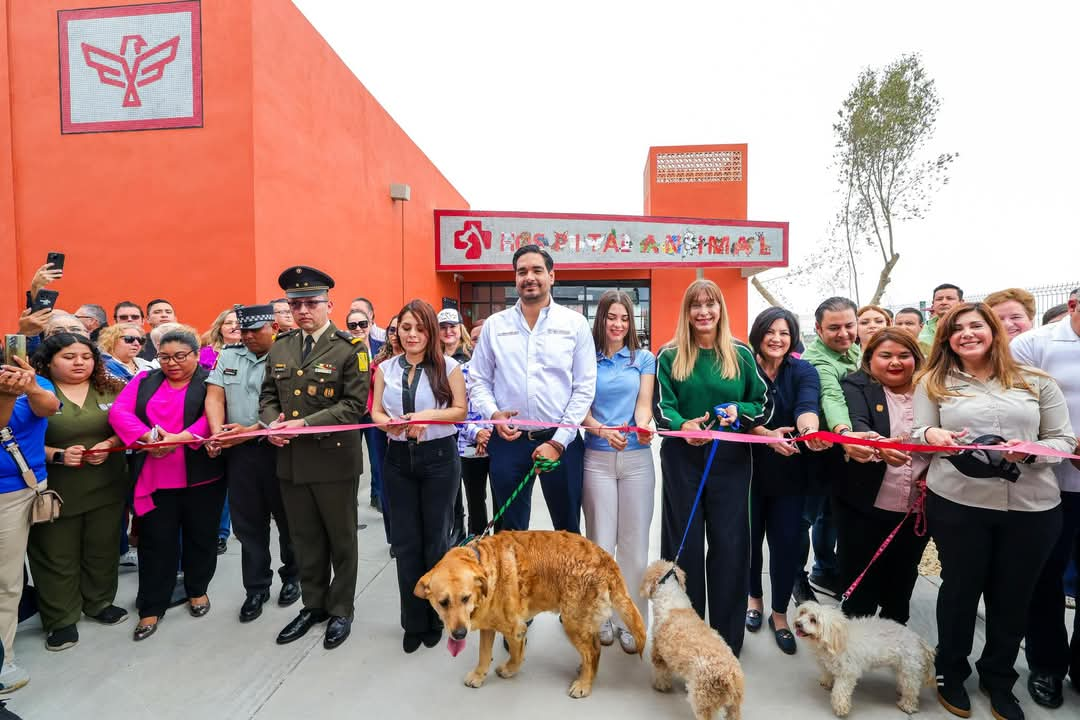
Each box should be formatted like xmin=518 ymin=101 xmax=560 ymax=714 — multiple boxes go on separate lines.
xmin=0 ymin=0 xmax=787 ymax=345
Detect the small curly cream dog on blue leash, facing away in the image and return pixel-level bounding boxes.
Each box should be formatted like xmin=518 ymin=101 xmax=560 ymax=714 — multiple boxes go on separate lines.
xmin=640 ymin=560 xmax=744 ymax=720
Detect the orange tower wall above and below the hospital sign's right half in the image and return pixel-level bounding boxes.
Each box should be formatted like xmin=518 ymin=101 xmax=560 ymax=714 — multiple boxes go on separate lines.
xmin=644 ymin=145 xmax=748 ymax=348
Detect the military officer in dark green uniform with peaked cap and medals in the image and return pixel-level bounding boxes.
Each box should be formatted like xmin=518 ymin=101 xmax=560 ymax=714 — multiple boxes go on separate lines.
xmin=259 ymin=266 xmax=370 ymax=649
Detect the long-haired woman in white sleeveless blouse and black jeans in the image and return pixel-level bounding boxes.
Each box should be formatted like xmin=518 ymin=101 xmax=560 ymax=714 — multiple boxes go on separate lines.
xmin=372 ymin=300 xmax=467 ymax=653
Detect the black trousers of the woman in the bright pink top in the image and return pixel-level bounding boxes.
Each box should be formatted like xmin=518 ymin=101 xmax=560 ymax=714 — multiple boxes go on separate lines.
xmin=135 ymin=480 xmax=226 ymax=617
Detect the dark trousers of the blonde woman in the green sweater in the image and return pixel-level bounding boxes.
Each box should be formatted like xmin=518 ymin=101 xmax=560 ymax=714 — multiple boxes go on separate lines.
xmin=660 ymin=437 xmax=751 ymax=656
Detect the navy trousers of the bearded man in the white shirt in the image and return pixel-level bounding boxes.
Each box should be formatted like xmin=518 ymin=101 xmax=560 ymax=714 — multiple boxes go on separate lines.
xmin=487 ymin=433 xmax=585 ymax=533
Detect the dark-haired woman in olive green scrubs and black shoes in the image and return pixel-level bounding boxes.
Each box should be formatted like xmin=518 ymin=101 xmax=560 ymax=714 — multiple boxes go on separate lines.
xmin=27 ymin=332 xmax=130 ymax=651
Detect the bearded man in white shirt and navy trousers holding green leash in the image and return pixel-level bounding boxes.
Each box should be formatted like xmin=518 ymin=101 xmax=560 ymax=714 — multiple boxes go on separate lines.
xmin=469 ymin=245 xmax=596 ymax=532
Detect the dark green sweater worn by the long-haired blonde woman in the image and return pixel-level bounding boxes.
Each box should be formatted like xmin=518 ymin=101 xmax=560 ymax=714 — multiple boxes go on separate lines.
xmin=657 ymin=341 xmax=767 ymax=432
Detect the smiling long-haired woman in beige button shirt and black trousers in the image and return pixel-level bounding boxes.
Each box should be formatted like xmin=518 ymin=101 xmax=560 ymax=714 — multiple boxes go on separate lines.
xmin=914 ymin=302 xmax=1077 ymax=720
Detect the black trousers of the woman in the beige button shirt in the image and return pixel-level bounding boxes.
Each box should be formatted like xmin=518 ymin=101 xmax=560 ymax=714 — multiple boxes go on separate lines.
xmin=927 ymin=490 xmax=1064 ymax=690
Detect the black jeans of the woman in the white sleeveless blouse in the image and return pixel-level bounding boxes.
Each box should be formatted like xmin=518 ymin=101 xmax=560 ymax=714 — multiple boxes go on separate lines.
xmin=382 ymin=435 xmax=461 ymax=633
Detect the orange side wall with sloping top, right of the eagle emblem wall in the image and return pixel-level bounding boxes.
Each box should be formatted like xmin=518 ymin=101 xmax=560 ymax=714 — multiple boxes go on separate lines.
xmin=253 ymin=0 xmax=470 ymax=327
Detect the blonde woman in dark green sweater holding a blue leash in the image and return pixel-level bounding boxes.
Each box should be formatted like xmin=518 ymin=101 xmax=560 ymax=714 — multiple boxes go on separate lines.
xmin=657 ymin=280 xmax=766 ymax=655
